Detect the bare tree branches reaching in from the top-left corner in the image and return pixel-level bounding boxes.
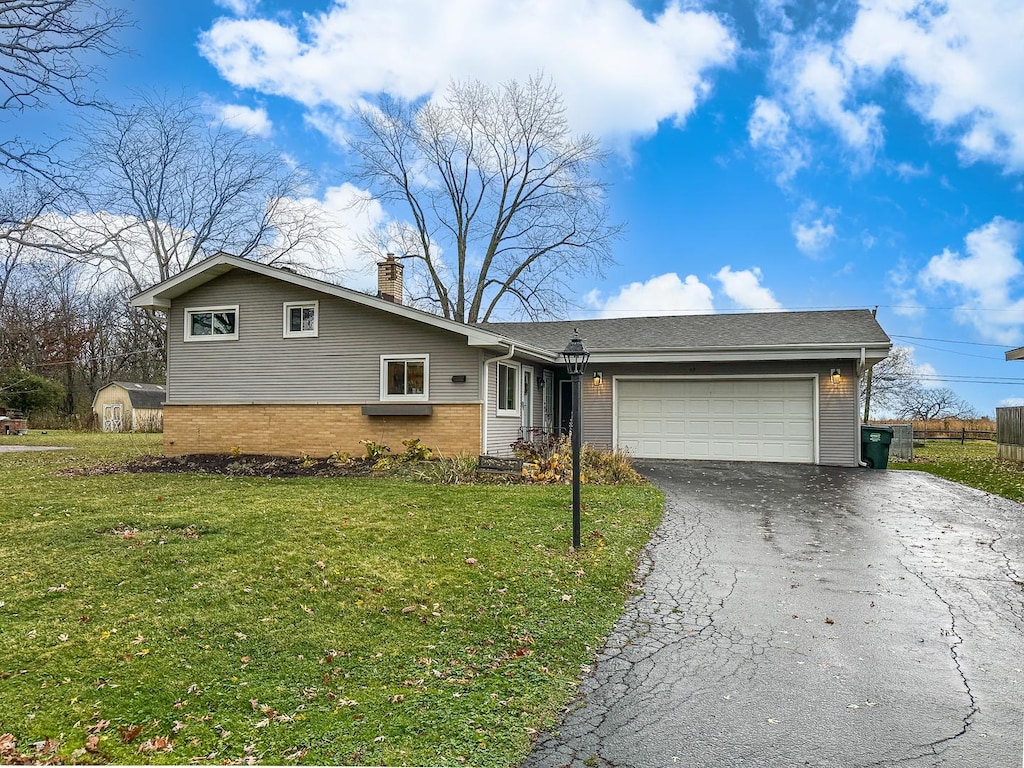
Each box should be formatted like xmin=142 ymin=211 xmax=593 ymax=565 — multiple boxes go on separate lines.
xmin=0 ymin=0 xmax=127 ymax=177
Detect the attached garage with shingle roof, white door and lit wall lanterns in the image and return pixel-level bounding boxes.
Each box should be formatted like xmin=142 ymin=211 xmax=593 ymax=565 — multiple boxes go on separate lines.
xmin=485 ymin=309 xmax=892 ymax=467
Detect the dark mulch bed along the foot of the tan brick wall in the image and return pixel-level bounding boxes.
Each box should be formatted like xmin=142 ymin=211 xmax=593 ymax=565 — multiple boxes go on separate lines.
xmin=62 ymin=454 xmax=374 ymax=477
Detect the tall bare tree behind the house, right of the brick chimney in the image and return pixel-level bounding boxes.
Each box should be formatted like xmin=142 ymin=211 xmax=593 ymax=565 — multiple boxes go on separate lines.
xmin=351 ymin=78 xmax=621 ymax=323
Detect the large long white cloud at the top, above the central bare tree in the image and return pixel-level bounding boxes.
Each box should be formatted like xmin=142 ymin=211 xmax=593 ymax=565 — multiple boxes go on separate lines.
xmin=200 ymin=0 xmax=737 ymax=138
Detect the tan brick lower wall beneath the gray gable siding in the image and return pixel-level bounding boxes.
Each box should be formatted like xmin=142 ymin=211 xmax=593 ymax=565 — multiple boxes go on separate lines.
xmin=164 ymin=403 xmax=481 ymax=457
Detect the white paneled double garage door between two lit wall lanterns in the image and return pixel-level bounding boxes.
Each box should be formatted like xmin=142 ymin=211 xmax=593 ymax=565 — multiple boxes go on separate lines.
xmin=616 ymin=379 xmax=814 ymax=464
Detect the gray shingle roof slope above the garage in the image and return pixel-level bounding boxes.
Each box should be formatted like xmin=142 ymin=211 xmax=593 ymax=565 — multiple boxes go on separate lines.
xmin=480 ymin=309 xmax=890 ymax=352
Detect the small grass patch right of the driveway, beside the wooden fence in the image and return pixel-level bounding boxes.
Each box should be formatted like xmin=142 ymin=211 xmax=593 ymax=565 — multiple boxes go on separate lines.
xmin=889 ymin=440 xmax=1024 ymax=502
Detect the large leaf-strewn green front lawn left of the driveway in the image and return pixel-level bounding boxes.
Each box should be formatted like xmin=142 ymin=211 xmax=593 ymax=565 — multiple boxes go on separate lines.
xmin=0 ymin=432 xmax=662 ymax=766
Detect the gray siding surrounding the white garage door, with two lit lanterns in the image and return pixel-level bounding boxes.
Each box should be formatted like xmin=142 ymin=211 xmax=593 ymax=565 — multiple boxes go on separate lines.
xmin=583 ymin=360 xmax=860 ymax=467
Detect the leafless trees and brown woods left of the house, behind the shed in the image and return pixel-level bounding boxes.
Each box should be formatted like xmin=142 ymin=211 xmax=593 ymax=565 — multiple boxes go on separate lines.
xmin=0 ymin=98 xmax=344 ymax=421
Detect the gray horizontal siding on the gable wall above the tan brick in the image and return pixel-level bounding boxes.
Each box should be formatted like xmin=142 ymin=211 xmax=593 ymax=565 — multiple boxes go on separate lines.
xmin=167 ymin=270 xmax=480 ymax=403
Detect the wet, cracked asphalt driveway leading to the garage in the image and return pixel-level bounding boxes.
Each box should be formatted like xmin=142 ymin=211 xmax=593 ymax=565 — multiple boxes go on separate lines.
xmin=523 ymin=462 xmax=1024 ymax=768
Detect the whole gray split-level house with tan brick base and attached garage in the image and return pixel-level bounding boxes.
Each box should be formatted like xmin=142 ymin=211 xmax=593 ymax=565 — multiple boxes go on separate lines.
xmin=132 ymin=254 xmax=891 ymax=466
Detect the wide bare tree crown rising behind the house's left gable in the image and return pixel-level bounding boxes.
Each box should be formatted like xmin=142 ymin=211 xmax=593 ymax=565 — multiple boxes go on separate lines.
xmin=33 ymin=93 xmax=331 ymax=291
